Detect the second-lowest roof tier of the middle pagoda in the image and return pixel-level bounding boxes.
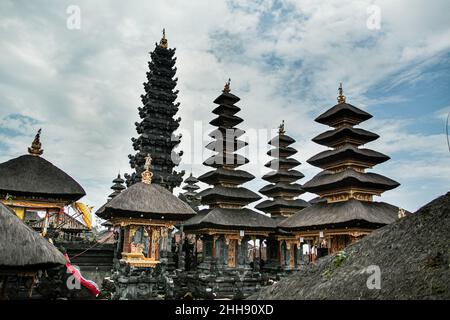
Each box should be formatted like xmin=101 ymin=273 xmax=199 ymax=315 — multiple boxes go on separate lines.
xmin=198 ymin=185 xmax=261 ymax=206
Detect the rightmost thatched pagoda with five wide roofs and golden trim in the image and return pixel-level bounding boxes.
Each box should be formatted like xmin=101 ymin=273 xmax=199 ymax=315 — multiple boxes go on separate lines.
xmin=279 ymin=84 xmax=399 ymax=254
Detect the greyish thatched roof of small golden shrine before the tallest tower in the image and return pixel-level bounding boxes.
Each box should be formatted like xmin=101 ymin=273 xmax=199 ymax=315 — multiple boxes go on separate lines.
xmin=96 ymin=182 xmax=195 ymax=220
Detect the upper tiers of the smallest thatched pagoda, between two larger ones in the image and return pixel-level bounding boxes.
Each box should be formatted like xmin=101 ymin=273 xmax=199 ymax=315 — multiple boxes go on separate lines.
xmin=255 ymin=121 xmax=309 ymax=219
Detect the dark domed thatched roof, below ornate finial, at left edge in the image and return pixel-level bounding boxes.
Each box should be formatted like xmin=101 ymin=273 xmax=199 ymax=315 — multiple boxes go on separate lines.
xmin=0 ymin=155 xmax=86 ymax=201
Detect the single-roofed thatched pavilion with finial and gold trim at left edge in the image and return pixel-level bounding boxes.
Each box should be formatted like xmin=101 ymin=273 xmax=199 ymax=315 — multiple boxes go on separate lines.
xmin=0 ymin=129 xmax=89 ymax=234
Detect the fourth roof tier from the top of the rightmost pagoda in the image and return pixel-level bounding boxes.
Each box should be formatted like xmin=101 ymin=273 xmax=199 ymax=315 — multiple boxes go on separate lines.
xmin=302 ymin=168 xmax=400 ymax=194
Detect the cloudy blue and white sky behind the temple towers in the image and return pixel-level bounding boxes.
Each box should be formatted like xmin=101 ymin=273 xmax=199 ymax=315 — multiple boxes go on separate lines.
xmin=0 ymin=0 xmax=450 ymax=218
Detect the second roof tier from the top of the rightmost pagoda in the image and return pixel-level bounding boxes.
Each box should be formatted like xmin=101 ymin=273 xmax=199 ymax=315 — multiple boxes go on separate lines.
xmin=312 ymin=127 xmax=380 ymax=147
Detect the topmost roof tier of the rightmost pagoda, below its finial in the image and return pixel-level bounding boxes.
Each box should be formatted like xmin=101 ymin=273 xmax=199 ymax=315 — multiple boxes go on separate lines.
xmin=315 ymin=103 xmax=372 ymax=126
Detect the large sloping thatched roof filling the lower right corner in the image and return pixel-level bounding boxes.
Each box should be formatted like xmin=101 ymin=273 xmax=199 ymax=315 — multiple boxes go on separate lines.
xmin=250 ymin=193 xmax=450 ymax=300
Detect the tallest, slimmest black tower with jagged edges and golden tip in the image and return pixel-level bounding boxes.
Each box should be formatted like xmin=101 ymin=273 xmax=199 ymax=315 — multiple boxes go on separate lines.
xmin=125 ymin=30 xmax=184 ymax=191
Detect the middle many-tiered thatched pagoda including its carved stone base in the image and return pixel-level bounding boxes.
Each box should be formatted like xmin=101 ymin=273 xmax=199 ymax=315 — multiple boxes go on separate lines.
xmin=184 ymin=81 xmax=276 ymax=297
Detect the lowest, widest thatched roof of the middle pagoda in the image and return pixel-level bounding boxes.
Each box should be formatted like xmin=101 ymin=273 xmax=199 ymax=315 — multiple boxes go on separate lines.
xmin=184 ymin=208 xmax=276 ymax=231
